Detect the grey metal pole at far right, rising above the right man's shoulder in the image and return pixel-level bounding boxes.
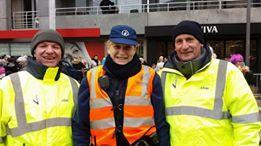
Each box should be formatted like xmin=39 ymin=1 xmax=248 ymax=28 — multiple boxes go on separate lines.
xmin=246 ymin=0 xmax=251 ymax=66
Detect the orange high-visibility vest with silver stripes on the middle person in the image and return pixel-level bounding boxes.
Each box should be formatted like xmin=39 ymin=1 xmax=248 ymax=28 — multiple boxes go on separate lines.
xmin=87 ymin=66 xmax=156 ymax=145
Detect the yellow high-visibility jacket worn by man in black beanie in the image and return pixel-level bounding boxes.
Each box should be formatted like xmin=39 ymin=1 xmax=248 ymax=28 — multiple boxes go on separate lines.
xmin=160 ymin=59 xmax=261 ymax=146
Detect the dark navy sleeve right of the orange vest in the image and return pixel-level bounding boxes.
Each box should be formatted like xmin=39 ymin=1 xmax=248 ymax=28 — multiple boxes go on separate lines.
xmin=151 ymin=74 xmax=170 ymax=146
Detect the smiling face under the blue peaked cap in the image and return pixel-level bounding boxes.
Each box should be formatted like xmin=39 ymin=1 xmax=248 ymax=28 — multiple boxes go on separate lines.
xmin=108 ymin=43 xmax=136 ymax=65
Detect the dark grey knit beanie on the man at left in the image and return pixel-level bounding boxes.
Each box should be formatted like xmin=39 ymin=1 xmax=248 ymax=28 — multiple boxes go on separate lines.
xmin=31 ymin=29 xmax=64 ymax=57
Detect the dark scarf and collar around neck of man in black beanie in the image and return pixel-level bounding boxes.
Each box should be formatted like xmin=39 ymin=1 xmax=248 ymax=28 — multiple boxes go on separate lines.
xmin=165 ymin=46 xmax=212 ymax=79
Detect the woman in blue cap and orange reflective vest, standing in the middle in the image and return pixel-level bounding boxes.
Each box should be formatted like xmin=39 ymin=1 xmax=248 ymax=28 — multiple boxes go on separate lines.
xmin=72 ymin=25 xmax=170 ymax=146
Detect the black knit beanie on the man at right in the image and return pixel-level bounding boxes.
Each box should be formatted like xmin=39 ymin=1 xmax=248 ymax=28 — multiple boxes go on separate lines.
xmin=172 ymin=20 xmax=205 ymax=44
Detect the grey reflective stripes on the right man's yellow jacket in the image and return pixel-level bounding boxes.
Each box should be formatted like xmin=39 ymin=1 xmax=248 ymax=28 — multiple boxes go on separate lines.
xmin=161 ymin=60 xmax=259 ymax=123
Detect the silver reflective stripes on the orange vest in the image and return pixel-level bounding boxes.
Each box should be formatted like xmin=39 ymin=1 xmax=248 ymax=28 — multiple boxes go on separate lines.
xmin=90 ymin=66 xmax=154 ymax=129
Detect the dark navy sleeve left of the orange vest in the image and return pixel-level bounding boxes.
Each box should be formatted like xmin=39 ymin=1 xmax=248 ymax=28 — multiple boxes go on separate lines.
xmin=72 ymin=78 xmax=91 ymax=146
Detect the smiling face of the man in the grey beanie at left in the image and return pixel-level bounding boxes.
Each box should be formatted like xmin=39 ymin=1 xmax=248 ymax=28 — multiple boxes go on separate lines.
xmin=34 ymin=42 xmax=62 ymax=67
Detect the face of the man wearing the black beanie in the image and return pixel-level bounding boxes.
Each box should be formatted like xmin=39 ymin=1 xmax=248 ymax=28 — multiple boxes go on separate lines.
xmin=174 ymin=34 xmax=203 ymax=61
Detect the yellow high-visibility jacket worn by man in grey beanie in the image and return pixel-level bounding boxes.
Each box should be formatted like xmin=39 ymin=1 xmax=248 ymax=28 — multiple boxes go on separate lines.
xmin=0 ymin=67 xmax=78 ymax=146
